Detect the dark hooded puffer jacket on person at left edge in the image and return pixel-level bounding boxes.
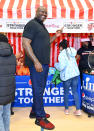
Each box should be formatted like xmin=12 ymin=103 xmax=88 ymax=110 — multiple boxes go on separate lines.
xmin=0 ymin=42 xmax=16 ymax=105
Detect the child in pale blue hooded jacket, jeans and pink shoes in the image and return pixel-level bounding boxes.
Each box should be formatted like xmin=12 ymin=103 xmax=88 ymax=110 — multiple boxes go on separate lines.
xmin=55 ymin=39 xmax=81 ymax=115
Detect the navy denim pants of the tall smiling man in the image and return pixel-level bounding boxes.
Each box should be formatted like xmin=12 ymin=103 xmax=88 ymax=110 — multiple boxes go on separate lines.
xmin=29 ymin=65 xmax=49 ymax=118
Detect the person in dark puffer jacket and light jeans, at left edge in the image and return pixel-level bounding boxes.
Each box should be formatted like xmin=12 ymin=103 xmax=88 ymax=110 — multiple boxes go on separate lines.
xmin=0 ymin=33 xmax=16 ymax=131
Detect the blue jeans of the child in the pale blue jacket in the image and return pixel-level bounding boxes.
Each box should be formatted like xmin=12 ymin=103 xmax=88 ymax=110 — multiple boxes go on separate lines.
xmin=63 ymin=76 xmax=80 ymax=110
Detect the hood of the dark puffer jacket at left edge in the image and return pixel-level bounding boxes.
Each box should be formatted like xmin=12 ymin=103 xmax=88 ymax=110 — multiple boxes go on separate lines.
xmin=0 ymin=42 xmax=13 ymax=57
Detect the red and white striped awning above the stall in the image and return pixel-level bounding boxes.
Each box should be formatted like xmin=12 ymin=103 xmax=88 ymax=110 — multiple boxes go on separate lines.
xmin=0 ymin=0 xmax=94 ymax=20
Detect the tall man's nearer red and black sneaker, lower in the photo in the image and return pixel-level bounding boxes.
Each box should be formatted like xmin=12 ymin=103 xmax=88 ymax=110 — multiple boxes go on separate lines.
xmin=35 ymin=118 xmax=55 ymax=130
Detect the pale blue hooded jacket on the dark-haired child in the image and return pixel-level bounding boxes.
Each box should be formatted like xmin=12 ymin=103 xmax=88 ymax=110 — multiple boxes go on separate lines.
xmin=55 ymin=47 xmax=80 ymax=81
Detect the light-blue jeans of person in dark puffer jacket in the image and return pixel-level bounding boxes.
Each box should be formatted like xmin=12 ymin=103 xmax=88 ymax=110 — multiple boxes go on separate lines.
xmin=0 ymin=103 xmax=11 ymax=131
